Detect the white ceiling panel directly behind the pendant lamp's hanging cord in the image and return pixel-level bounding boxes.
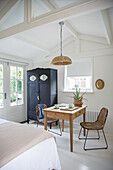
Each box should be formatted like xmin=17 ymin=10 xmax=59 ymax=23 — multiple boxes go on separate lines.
xmin=20 ymin=23 xmax=70 ymax=49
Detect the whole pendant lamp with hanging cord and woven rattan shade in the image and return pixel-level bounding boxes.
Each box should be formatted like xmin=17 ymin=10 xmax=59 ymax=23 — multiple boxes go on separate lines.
xmin=51 ymin=22 xmax=72 ymax=65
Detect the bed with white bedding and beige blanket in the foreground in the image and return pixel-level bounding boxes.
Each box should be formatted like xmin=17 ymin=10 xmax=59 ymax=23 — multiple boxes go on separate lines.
xmin=0 ymin=119 xmax=61 ymax=170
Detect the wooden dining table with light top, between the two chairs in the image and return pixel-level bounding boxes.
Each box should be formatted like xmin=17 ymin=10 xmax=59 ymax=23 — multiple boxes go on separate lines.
xmin=43 ymin=106 xmax=87 ymax=152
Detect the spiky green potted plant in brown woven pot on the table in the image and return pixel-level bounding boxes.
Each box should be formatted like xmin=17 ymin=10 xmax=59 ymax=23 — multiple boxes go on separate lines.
xmin=73 ymin=85 xmax=86 ymax=107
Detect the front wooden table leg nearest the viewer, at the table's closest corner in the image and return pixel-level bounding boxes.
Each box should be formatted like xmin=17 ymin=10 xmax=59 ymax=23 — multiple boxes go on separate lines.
xmin=70 ymin=115 xmax=73 ymax=152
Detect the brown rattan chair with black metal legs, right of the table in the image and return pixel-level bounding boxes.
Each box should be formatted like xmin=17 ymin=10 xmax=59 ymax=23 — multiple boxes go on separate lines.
xmin=78 ymin=108 xmax=108 ymax=150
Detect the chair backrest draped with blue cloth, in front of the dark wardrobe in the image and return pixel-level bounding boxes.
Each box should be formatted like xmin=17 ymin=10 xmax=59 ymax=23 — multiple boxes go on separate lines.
xmin=36 ymin=104 xmax=47 ymax=120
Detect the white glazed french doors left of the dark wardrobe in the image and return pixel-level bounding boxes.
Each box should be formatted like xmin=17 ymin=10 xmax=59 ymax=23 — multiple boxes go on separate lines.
xmin=0 ymin=62 xmax=25 ymax=122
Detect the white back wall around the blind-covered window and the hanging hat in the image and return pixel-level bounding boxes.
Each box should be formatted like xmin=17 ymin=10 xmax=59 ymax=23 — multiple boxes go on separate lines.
xmin=35 ymin=41 xmax=113 ymax=134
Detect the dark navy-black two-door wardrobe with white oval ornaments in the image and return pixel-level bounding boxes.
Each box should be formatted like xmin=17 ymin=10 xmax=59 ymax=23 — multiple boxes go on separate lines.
xmin=27 ymin=68 xmax=57 ymax=123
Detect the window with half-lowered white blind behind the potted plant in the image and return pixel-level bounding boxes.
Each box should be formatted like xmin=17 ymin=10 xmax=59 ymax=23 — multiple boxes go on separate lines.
xmin=64 ymin=59 xmax=92 ymax=92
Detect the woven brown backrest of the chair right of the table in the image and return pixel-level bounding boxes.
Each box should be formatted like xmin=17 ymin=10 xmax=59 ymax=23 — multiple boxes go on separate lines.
xmin=97 ymin=108 xmax=108 ymax=127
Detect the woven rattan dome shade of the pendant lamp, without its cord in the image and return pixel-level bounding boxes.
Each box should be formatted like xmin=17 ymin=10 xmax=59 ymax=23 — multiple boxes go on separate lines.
xmin=51 ymin=56 xmax=72 ymax=65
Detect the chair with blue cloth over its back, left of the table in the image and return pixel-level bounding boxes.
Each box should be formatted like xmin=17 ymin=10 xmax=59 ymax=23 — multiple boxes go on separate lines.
xmin=36 ymin=104 xmax=62 ymax=136
